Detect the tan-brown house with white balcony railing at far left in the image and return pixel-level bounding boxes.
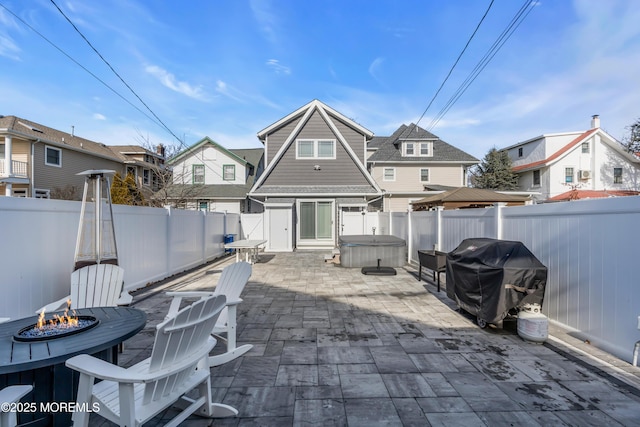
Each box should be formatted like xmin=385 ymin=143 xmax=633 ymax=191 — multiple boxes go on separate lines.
xmin=0 ymin=116 xmax=131 ymax=200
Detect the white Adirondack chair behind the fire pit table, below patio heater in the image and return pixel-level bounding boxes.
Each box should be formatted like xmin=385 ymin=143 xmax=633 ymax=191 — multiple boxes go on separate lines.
xmin=36 ymin=264 xmax=133 ymax=313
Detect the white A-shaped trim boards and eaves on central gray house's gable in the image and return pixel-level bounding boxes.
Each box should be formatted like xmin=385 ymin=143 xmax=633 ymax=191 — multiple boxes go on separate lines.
xmin=250 ymin=99 xmax=382 ymax=194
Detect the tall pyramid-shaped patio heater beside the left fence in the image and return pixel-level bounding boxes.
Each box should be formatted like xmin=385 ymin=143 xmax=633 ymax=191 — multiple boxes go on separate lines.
xmin=73 ymin=170 xmax=118 ymax=271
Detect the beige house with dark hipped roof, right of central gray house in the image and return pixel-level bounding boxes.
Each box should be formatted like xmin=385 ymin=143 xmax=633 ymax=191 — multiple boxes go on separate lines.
xmin=367 ymin=123 xmax=478 ymax=212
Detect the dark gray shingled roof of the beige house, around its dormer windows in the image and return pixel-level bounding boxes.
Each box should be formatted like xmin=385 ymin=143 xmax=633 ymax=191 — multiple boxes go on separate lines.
xmin=367 ymin=123 xmax=479 ymax=164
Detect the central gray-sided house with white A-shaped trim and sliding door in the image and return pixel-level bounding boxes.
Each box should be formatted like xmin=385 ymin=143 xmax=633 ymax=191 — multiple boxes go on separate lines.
xmin=249 ymin=100 xmax=382 ymax=251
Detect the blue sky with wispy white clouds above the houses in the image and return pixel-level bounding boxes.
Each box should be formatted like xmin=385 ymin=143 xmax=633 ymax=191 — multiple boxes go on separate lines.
xmin=0 ymin=0 xmax=640 ymax=158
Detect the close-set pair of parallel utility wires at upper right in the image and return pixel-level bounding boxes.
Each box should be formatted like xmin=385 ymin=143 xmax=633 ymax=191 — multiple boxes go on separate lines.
xmin=427 ymin=0 xmax=535 ymax=131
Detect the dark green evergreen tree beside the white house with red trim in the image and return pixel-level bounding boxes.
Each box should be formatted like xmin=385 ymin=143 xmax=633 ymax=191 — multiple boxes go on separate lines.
xmin=471 ymin=148 xmax=518 ymax=191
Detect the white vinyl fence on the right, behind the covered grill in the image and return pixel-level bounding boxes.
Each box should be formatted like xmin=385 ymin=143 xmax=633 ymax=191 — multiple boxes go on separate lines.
xmin=372 ymin=197 xmax=640 ymax=362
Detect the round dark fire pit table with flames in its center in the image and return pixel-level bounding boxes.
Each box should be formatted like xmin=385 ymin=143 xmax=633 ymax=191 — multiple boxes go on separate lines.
xmin=0 ymin=307 xmax=147 ymax=427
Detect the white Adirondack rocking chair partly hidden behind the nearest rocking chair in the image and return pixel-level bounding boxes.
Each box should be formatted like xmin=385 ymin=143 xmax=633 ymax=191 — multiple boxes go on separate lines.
xmin=167 ymin=261 xmax=253 ymax=367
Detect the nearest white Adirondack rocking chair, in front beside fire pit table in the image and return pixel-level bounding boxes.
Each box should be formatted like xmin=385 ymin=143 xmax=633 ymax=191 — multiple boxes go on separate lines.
xmin=66 ymin=295 xmax=238 ymax=427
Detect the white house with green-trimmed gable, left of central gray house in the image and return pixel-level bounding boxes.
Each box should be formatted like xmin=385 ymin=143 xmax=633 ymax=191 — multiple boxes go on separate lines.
xmin=164 ymin=137 xmax=264 ymax=213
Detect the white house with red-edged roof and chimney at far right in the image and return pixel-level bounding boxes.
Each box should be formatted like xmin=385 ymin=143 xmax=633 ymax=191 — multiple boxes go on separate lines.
xmin=504 ymin=115 xmax=640 ymax=200
